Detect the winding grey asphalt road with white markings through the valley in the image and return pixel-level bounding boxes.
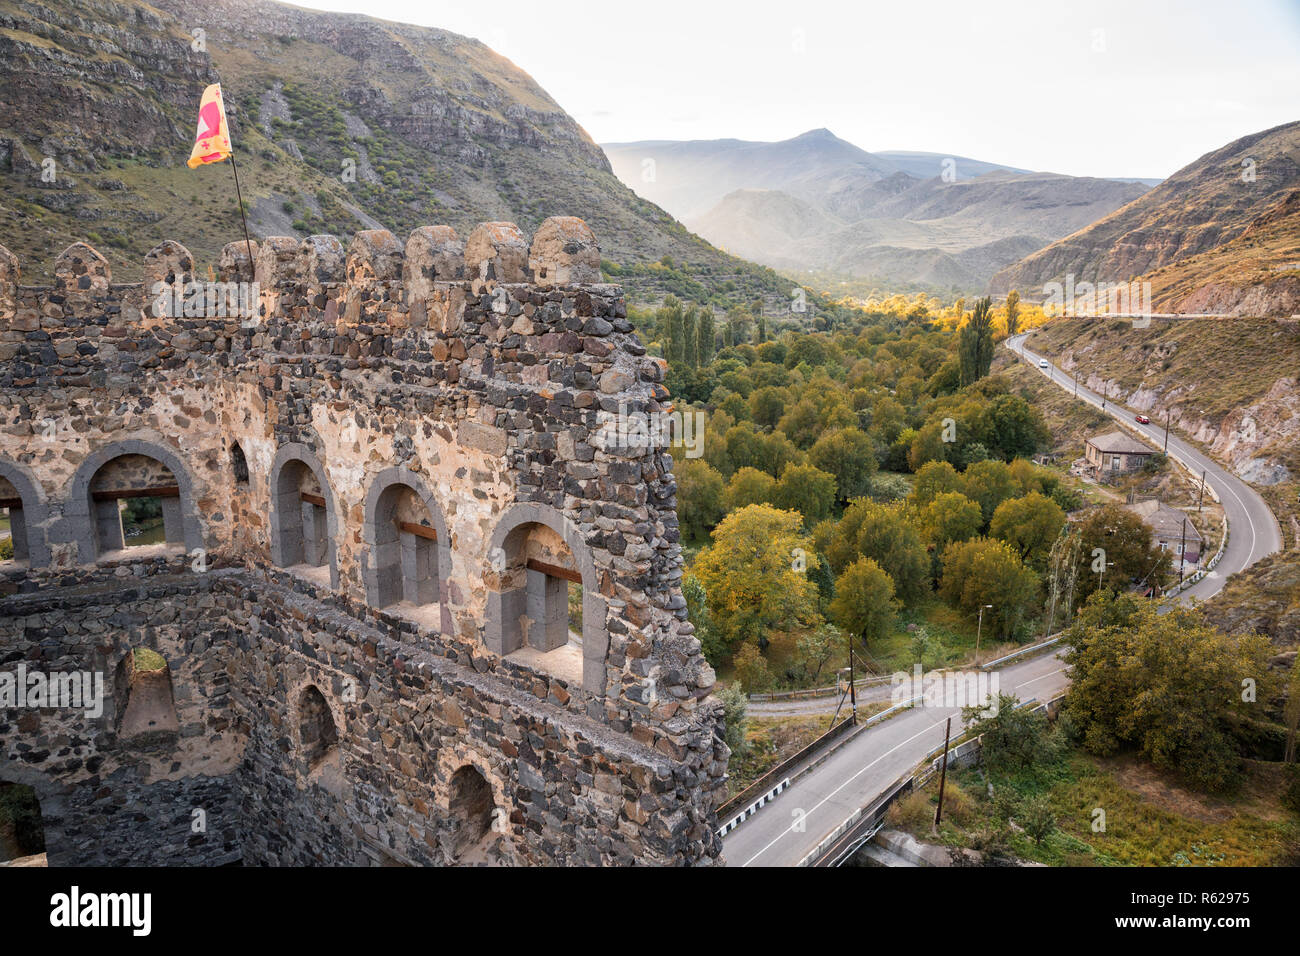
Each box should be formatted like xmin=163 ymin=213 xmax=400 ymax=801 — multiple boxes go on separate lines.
xmin=723 ymin=334 xmax=1282 ymax=866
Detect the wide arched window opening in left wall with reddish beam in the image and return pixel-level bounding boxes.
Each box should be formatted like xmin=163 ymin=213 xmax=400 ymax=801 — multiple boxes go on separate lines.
xmin=90 ymin=454 xmax=185 ymax=558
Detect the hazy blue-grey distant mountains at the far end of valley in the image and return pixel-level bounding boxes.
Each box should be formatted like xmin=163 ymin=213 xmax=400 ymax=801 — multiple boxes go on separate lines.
xmin=603 ymin=129 xmax=1147 ymax=293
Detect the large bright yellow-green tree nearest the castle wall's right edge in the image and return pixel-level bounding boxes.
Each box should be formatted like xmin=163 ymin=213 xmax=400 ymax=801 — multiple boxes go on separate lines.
xmin=694 ymin=505 xmax=819 ymax=648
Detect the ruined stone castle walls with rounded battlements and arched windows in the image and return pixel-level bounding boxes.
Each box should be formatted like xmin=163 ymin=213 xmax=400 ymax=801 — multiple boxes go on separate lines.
xmin=0 ymin=219 xmax=728 ymax=865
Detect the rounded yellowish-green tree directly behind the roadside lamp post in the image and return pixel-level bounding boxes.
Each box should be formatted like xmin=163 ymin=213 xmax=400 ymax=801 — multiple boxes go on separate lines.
xmin=939 ymin=537 xmax=1039 ymax=639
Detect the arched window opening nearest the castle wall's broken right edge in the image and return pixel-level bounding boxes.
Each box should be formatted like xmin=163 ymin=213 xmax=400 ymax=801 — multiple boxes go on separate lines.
xmin=501 ymin=523 xmax=582 ymax=684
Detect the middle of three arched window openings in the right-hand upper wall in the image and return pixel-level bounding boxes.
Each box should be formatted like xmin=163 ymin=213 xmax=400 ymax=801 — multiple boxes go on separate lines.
xmin=371 ymin=484 xmax=438 ymax=626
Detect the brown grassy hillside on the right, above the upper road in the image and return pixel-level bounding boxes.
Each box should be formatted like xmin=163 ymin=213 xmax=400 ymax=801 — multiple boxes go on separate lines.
xmin=989 ymin=121 xmax=1300 ymax=315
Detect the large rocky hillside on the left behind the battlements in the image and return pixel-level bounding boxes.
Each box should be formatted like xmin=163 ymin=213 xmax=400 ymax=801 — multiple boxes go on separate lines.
xmin=0 ymin=0 xmax=789 ymax=300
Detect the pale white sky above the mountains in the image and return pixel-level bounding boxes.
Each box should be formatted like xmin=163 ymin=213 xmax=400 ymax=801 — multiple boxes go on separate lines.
xmin=299 ymin=0 xmax=1300 ymax=177
